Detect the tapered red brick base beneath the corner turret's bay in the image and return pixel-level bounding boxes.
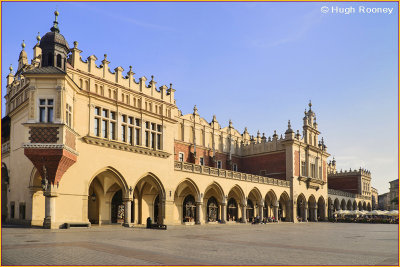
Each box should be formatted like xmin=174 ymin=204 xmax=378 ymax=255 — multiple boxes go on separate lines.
xmin=24 ymin=148 xmax=77 ymax=184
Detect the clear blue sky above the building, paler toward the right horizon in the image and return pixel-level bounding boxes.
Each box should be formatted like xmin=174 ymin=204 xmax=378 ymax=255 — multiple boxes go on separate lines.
xmin=1 ymin=2 xmax=398 ymax=194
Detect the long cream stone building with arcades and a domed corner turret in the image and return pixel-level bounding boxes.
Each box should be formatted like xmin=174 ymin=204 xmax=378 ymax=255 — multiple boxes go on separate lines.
xmin=2 ymin=10 xmax=371 ymax=228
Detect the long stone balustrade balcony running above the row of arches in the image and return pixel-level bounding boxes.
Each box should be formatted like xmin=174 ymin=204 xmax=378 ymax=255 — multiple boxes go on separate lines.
xmin=174 ymin=161 xmax=290 ymax=187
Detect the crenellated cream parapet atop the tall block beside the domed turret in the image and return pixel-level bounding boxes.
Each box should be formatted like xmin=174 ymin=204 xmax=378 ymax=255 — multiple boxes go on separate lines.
xmin=68 ymin=41 xmax=175 ymax=107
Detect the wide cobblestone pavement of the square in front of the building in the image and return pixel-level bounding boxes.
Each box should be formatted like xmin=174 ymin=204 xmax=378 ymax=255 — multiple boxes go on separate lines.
xmin=1 ymin=222 xmax=399 ymax=265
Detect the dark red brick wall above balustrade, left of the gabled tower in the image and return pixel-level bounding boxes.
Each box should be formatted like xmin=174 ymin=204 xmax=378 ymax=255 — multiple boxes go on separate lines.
xmin=240 ymin=152 xmax=286 ymax=180
